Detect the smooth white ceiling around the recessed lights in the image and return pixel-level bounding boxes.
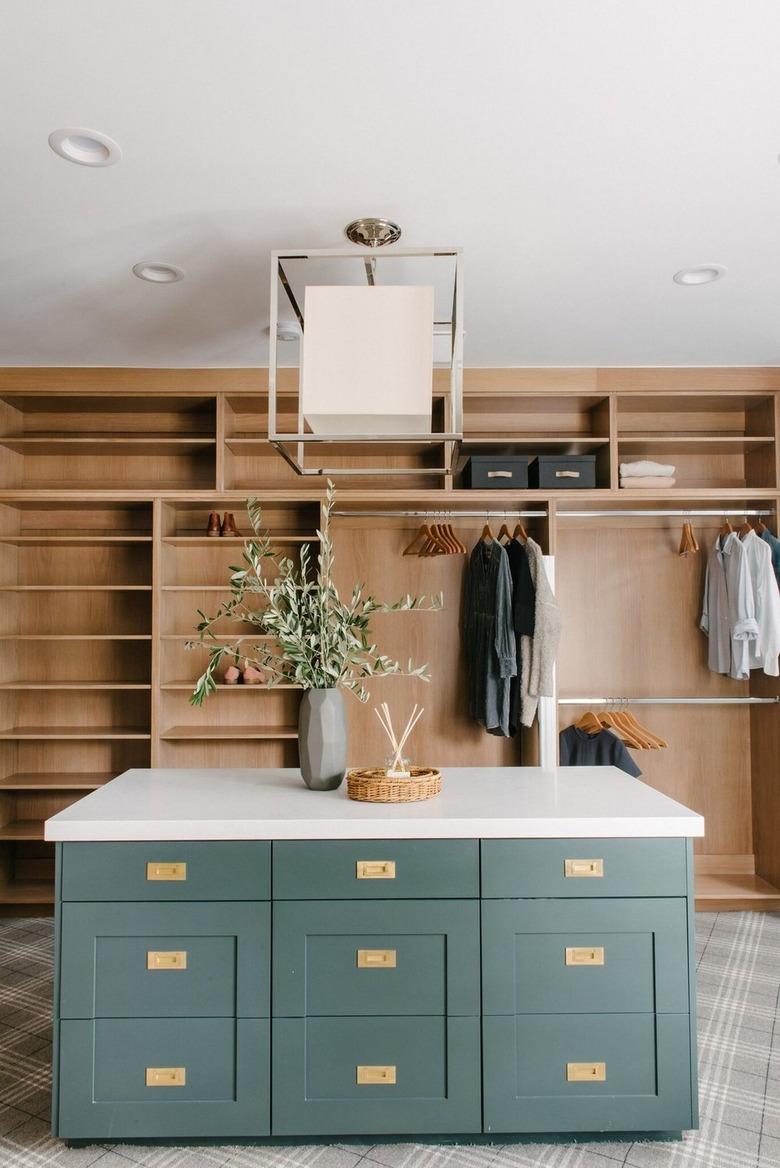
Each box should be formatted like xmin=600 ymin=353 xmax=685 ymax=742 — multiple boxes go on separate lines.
xmin=0 ymin=0 xmax=780 ymax=366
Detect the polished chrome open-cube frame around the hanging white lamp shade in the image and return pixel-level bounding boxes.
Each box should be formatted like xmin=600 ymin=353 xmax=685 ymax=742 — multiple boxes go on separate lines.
xmin=269 ymin=246 xmax=464 ymax=478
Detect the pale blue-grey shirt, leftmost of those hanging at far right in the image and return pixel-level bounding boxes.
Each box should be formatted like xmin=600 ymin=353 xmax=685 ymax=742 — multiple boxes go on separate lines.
xmin=699 ymin=531 xmax=758 ymax=681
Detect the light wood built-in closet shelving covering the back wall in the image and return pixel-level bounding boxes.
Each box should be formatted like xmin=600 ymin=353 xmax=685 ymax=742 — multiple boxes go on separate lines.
xmin=0 ymin=369 xmax=780 ymax=912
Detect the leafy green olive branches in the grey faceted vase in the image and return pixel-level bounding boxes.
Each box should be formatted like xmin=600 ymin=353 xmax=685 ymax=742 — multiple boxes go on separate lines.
xmin=187 ymin=481 xmax=444 ymax=705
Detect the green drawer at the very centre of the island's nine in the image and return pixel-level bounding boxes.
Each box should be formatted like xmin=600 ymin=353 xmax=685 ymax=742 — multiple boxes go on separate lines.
xmin=273 ymin=901 xmax=480 ymax=1017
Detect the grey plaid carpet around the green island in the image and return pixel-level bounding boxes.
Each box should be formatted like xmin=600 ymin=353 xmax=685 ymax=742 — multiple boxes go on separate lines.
xmin=0 ymin=913 xmax=780 ymax=1168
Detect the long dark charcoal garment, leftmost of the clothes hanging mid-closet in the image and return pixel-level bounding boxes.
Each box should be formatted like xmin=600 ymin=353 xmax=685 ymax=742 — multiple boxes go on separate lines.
xmin=464 ymin=540 xmax=517 ymax=736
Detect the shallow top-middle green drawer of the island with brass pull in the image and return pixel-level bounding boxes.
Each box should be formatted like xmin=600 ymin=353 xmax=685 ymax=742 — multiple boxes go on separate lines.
xmin=273 ymin=840 xmax=480 ymax=901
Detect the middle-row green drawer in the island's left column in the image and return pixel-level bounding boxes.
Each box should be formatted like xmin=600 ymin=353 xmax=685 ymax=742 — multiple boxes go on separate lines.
xmin=60 ymin=901 xmax=271 ymax=1018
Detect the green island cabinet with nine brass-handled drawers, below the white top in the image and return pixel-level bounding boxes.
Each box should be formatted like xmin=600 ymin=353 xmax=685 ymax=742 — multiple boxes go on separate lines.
xmin=50 ymin=772 xmax=697 ymax=1142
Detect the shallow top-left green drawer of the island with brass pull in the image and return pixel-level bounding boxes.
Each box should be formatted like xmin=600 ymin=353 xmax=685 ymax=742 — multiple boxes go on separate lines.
xmin=62 ymin=840 xmax=271 ymax=901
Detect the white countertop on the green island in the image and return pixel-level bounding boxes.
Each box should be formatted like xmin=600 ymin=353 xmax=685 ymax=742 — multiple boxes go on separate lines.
xmin=46 ymin=766 xmax=704 ymax=841
